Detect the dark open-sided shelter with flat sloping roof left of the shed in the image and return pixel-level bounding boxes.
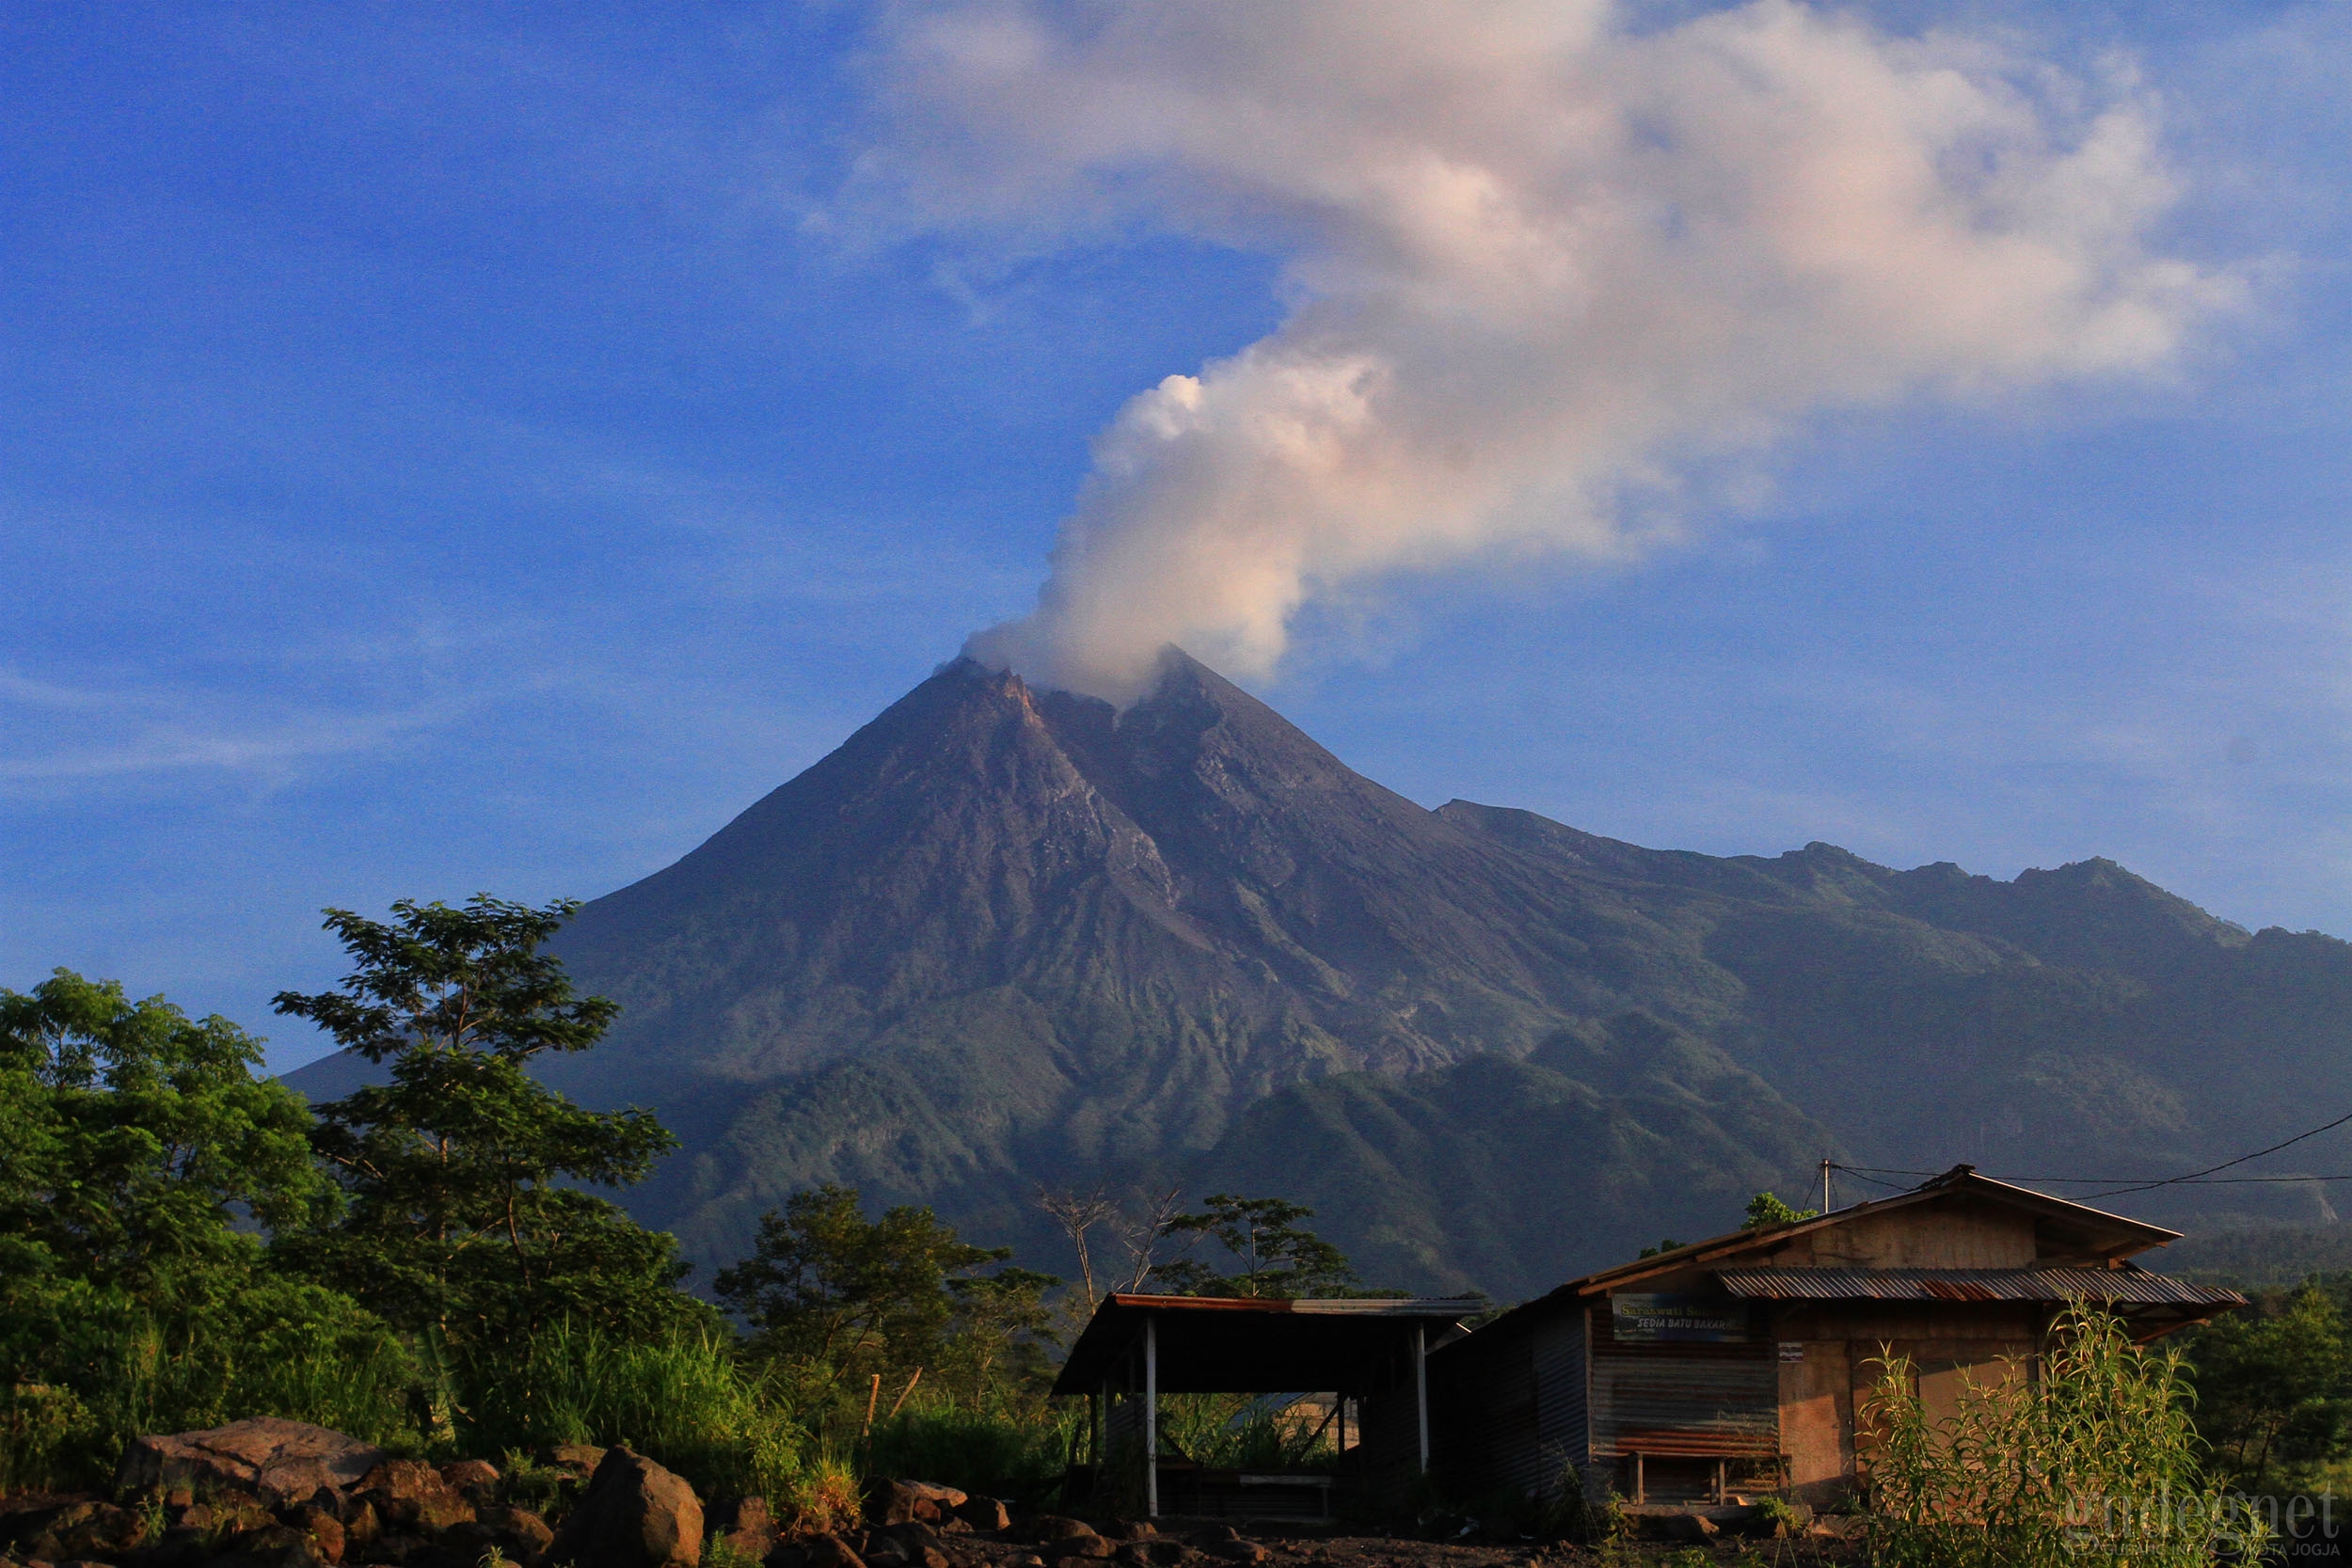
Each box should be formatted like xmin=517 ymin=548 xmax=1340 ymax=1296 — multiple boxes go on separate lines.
xmin=1054 ymin=1295 xmax=1486 ymax=1516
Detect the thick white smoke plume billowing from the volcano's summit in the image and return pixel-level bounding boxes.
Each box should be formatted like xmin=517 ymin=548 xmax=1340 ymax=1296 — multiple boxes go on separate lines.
xmin=882 ymin=0 xmax=2230 ymax=698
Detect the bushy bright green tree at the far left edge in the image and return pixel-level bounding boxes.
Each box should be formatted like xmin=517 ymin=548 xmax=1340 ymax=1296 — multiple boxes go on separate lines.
xmin=0 ymin=969 xmax=407 ymax=1491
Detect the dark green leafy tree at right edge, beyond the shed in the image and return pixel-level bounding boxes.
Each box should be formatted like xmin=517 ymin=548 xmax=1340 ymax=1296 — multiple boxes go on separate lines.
xmin=2183 ymin=1284 xmax=2352 ymax=1491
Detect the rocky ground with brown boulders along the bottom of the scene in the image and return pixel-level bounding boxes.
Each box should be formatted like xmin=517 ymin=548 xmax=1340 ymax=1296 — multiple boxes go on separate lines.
xmin=0 ymin=1420 xmax=1853 ymax=1568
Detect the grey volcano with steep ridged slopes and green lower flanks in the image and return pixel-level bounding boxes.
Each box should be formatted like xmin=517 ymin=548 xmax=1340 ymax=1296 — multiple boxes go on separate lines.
xmin=294 ymin=649 xmax=2352 ymax=1295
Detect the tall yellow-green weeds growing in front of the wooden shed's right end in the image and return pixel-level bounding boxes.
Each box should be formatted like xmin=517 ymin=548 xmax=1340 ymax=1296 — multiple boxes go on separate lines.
xmin=1858 ymin=1305 xmax=2263 ymax=1568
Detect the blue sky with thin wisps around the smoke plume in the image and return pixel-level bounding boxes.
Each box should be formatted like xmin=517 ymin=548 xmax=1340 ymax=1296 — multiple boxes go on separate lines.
xmin=0 ymin=0 xmax=2352 ymax=1068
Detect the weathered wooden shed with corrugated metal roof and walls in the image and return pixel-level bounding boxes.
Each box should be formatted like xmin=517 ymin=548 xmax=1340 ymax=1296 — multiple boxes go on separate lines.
xmin=1428 ymin=1166 xmax=2247 ymax=1507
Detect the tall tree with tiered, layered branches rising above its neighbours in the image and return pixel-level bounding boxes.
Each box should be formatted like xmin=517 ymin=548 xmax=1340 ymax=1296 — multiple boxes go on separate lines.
xmin=276 ymin=894 xmax=699 ymax=1354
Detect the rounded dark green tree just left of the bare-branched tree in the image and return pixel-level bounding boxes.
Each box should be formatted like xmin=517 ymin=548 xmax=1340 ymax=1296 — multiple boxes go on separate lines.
xmin=718 ymin=1182 xmax=1021 ymax=1385
